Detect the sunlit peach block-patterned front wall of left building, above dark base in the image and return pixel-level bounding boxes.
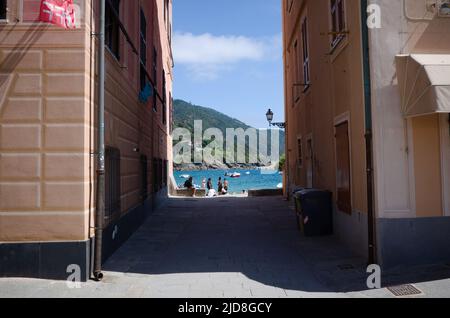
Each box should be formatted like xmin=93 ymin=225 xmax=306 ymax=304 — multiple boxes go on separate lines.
xmin=0 ymin=0 xmax=92 ymax=242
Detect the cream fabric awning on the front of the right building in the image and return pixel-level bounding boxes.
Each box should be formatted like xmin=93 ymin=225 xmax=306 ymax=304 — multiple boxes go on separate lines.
xmin=395 ymin=54 xmax=450 ymax=117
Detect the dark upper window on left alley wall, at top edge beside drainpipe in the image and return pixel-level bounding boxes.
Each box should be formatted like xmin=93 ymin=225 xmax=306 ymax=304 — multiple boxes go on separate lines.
xmin=105 ymin=0 xmax=120 ymax=59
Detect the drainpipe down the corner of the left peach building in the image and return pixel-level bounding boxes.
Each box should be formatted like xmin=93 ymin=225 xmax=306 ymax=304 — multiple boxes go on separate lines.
xmin=94 ymin=0 xmax=105 ymax=281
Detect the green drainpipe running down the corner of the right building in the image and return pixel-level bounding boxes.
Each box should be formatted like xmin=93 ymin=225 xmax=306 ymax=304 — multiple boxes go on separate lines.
xmin=361 ymin=0 xmax=377 ymax=264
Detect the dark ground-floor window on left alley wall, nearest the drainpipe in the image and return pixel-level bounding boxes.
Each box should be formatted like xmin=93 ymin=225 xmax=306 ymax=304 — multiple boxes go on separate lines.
xmin=105 ymin=147 xmax=121 ymax=226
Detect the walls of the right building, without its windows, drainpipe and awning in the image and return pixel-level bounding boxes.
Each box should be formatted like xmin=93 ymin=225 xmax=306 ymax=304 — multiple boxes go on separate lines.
xmin=283 ymin=0 xmax=450 ymax=267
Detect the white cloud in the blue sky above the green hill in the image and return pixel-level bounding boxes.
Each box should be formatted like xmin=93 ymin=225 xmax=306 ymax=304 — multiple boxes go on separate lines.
xmin=173 ymin=32 xmax=281 ymax=80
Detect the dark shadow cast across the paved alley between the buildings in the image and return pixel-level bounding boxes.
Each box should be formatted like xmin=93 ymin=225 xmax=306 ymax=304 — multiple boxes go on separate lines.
xmin=105 ymin=197 xmax=450 ymax=292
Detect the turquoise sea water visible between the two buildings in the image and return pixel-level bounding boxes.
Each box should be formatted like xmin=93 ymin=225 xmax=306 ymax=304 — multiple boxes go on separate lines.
xmin=174 ymin=170 xmax=283 ymax=193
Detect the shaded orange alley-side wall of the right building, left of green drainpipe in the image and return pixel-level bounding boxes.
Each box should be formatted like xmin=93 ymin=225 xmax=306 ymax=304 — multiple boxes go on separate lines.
xmin=283 ymin=1 xmax=366 ymax=212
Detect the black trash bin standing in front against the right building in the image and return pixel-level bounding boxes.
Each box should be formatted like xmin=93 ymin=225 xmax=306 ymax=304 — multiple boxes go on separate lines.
xmin=294 ymin=189 xmax=333 ymax=236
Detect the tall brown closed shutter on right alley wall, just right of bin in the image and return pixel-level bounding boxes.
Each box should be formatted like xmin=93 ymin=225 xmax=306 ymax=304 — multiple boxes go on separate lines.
xmin=336 ymin=122 xmax=352 ymax=214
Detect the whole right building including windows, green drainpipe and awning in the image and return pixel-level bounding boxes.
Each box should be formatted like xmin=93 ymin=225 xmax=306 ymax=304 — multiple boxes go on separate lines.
xmin=283 ymin=0 xmax=450 ymax=267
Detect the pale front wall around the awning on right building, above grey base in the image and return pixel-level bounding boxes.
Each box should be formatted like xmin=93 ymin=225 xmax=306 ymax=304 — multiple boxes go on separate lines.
xmin=370 ymin=0 xmax=450 ymax=218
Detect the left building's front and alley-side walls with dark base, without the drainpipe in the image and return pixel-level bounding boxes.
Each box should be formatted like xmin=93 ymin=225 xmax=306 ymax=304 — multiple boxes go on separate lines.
xmin=0 ymin=0 xmax=173 ymax=279
